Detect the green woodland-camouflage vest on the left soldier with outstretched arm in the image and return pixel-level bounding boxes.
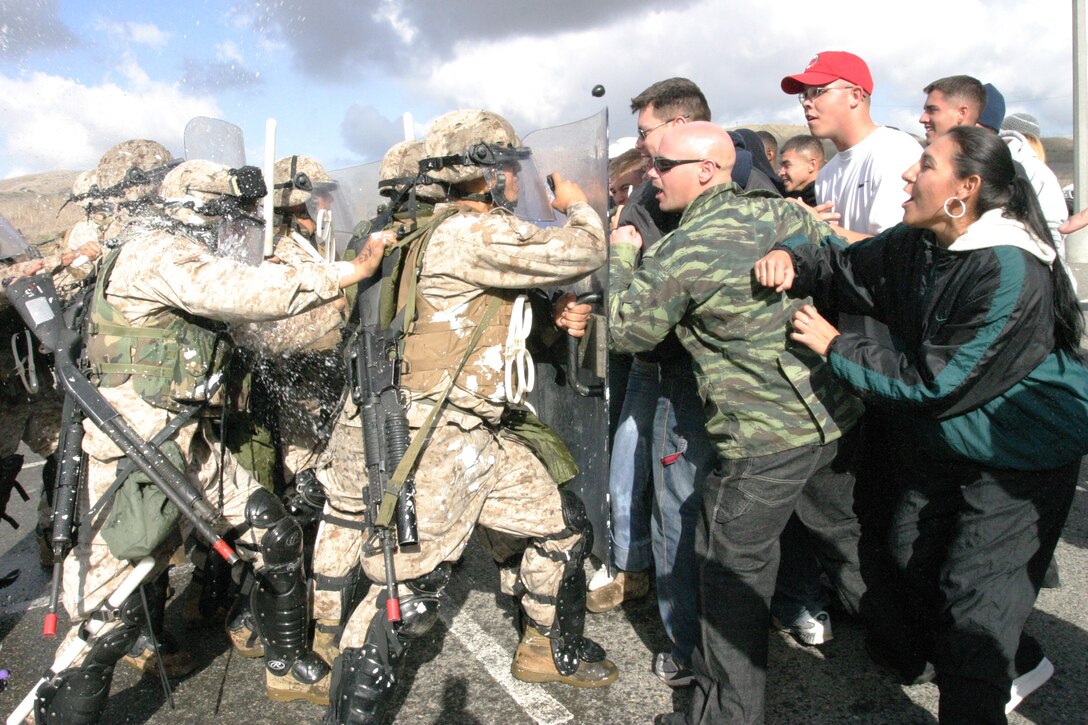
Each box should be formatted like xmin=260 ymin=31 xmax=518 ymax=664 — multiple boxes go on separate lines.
xmin=86 ymin=249 xmax=231 ymax=411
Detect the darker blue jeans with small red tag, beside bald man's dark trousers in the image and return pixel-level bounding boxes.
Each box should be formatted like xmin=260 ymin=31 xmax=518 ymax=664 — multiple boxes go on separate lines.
xmin=653 ymin=360 xmax=717 ymax=666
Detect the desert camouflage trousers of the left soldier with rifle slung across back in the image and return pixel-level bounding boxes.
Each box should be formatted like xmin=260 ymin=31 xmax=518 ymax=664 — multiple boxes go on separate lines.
xmin=56 ymin=384 xmax=272 ymax=664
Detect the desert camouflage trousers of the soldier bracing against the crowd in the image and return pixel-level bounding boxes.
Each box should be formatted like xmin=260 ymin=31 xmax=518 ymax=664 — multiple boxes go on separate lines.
xmin=341 ymin=419 xmax=582 ymax=649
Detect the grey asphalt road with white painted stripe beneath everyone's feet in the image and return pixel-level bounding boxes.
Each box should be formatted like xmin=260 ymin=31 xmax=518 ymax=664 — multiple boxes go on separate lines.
xmin=0 ymin=448 xmax=1088 ymax=725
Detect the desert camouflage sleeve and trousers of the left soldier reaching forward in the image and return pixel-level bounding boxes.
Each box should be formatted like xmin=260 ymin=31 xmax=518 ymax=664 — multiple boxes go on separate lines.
xmin=35 ymin=204 xmax=342 ymax=718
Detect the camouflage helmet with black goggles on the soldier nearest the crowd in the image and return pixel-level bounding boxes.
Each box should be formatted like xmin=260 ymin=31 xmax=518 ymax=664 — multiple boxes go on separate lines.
xmin=423 ymin=110 xmax=521 ymax=184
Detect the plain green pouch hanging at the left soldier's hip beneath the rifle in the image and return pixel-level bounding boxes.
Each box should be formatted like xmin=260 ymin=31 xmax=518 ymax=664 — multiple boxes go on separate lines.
xmin=101 ymin=441 xmax=185 ymax=560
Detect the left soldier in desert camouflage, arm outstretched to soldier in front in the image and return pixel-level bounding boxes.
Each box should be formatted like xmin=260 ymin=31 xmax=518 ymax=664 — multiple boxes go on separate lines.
xmin=28 ymin=155 xmax=380 ymax=723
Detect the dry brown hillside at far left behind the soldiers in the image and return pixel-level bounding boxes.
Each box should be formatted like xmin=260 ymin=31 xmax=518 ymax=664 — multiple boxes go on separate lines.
xmin=0 ymin=171 xmax=83 ymax=254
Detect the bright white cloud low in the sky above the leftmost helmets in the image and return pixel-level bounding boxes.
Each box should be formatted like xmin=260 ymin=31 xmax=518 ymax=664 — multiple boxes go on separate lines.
xmin=0 ymin=69 xmax=219 ymax=177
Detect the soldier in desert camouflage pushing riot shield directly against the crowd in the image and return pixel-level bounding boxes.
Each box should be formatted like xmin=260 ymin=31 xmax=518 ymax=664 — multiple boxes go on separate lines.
xmin=326 ymin=111 xmax=617 ymax=723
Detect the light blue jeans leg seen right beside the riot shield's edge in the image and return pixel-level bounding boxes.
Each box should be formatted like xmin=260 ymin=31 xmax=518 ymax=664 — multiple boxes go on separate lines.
xmin=608 ymin=359 xmax=658 ymax=572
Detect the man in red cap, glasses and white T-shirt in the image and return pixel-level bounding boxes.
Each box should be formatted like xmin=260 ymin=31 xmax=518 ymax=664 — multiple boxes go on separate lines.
xmin=782 ymin=50 xmax=922 ymax=242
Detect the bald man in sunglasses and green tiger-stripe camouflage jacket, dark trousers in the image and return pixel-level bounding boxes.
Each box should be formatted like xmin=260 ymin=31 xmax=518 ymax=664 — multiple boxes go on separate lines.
xmin=609 ymin=123 xmax=864 ymax=723
